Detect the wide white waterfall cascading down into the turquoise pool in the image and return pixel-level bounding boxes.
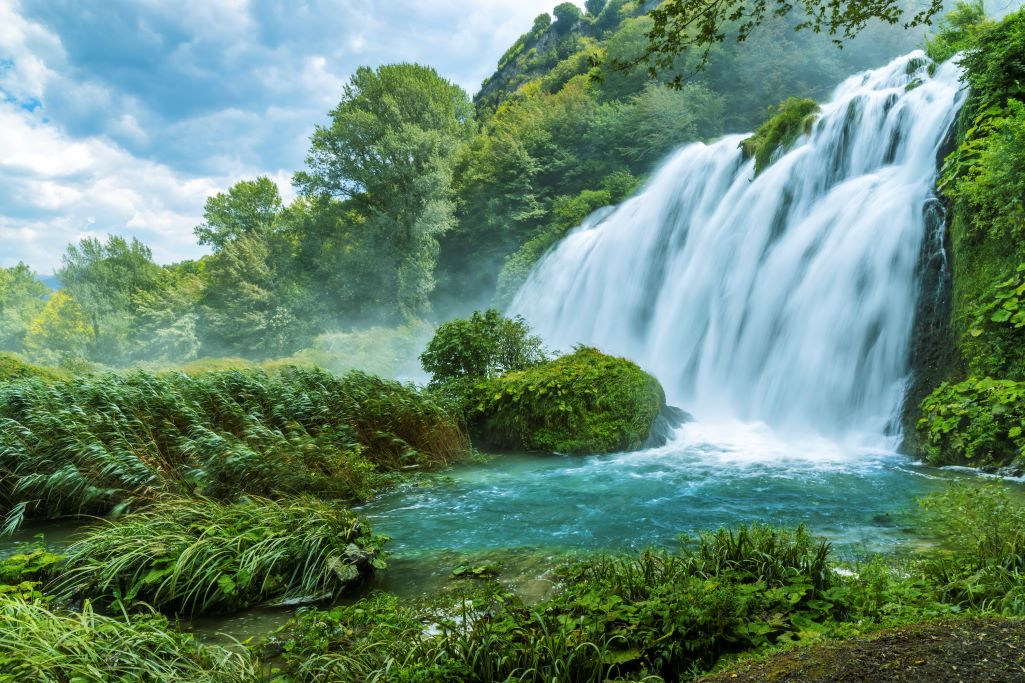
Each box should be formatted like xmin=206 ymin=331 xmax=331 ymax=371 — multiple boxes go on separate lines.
xmin=509 ymin=51 xmax=964 ymax=447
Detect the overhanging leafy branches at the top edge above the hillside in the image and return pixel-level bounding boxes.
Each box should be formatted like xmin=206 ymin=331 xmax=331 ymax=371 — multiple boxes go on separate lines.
xmin=645 ymin=0 xmax=943 ymax=84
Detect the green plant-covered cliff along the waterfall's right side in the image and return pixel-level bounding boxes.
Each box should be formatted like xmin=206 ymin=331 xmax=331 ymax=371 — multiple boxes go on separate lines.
xmin=918 ymin=3 xmax=1025 ymax=469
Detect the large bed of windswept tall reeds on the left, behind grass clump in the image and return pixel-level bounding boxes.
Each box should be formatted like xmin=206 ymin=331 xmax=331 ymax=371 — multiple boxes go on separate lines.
xmin=0 ymin=368 xmax=469 ymax=527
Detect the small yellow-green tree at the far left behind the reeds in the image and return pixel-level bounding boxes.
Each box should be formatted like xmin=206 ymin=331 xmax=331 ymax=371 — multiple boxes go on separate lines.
xmin=25 ymin=289 xmax=94 ymax=363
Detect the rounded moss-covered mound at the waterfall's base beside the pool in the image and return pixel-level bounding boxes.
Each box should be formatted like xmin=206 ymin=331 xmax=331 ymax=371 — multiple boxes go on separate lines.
xmin=467 ymin=348 xmax=665 ymax=453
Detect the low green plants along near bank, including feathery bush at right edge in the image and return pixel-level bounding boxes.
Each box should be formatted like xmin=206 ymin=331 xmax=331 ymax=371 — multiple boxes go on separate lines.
xmin=266 ymin=487 xmax=1025 ymax=683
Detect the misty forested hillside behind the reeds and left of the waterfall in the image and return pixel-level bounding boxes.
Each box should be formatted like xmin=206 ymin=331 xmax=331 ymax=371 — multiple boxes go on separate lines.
xmin=0 ymin=0 xmax=923 ymax=372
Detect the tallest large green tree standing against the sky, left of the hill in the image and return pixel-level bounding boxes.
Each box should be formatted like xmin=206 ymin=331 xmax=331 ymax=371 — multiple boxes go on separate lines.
xmin=294 ymin=64 xmax=474 ymax=319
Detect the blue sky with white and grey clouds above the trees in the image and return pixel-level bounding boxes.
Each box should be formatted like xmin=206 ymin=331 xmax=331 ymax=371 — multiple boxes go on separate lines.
xmin=0 ymin=0 xmax=559 ymax=274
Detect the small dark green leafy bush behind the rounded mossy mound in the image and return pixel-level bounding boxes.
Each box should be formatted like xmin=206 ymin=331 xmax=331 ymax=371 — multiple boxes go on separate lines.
xmin=420 ymin=309 xmax=547 ymax=386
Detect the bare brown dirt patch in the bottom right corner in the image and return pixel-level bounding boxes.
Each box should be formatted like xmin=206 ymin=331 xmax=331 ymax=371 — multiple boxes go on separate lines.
xmin=699 ymin=618 xmax=1025 ymax=683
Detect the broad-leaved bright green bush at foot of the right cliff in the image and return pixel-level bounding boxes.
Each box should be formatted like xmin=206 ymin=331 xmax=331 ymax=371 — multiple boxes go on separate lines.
xmin=918 ymin=377 xmax=1025 ymax=469
